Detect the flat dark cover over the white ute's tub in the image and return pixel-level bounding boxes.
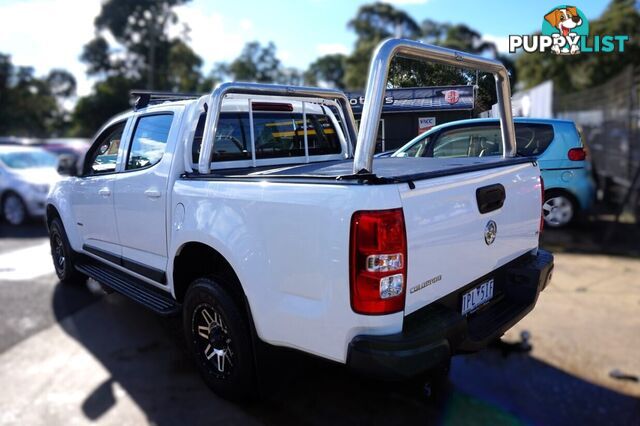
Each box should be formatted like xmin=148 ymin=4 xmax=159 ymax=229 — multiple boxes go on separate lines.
xmin=186 ymin=157 xmax=535 ymax=183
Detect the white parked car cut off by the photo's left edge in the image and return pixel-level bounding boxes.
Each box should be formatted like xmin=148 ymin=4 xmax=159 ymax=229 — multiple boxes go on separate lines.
xmin=0 ymin=145 xmax=61 ymax=225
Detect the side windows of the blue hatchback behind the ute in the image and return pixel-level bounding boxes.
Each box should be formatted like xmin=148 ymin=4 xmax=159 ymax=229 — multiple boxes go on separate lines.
xmin=432 ymin=123 xmax=554 ymax=157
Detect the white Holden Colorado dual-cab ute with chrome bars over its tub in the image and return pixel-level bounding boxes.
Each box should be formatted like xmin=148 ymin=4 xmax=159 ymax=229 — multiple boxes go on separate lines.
xmin=47 ymin=39 xmax=553 ymax=398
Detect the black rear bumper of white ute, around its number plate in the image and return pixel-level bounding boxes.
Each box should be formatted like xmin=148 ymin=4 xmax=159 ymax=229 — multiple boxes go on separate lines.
xmin=347 ymin=250 xmax=553 ymax=380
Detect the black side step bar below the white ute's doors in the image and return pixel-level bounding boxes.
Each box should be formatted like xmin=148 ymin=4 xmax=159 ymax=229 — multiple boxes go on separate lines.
xmin=76 ymin=256 xmax=181 ymax=316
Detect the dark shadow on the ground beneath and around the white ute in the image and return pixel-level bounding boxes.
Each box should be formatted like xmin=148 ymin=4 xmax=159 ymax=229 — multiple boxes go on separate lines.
xmin=53 ymin=292 xmax=640 ymax=425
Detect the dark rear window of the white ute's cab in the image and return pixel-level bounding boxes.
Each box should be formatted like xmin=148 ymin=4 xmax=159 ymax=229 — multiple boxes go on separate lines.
xmin=192 ymin=112 xmax=342 ymax=163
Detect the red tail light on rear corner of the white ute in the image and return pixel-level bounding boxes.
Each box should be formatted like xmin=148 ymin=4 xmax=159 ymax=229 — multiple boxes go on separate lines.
xmin=350 ymin=209 xmax=407 ymax=315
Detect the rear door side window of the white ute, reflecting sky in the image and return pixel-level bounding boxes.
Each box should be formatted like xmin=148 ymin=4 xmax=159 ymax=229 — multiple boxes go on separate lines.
xmin=126 ymin=114 xmax=173 ymax=170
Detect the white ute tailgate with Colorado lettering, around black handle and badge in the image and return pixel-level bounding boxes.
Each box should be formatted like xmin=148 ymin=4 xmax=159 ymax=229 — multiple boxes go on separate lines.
xmin=400 ymin=163 xmax=541 ymax=315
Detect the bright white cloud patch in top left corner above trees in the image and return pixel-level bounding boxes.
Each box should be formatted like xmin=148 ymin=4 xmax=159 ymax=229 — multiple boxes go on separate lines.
xmin=0 ymin=0 xmax=100 ymax=95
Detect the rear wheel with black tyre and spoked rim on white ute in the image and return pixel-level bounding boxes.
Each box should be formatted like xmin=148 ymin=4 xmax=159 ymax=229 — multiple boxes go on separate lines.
xmin=183 ymin=277 xmax=255 ymax=400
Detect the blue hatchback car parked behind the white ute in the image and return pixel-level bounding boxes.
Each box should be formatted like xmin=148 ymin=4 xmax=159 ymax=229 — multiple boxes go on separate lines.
xmin=392 ymin=118 xmax=595 ymax=228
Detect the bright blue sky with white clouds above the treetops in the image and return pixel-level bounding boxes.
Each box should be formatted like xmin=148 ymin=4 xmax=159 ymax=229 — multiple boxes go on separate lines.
xmin=0 ymin=0 xmax=608 ymax=95
